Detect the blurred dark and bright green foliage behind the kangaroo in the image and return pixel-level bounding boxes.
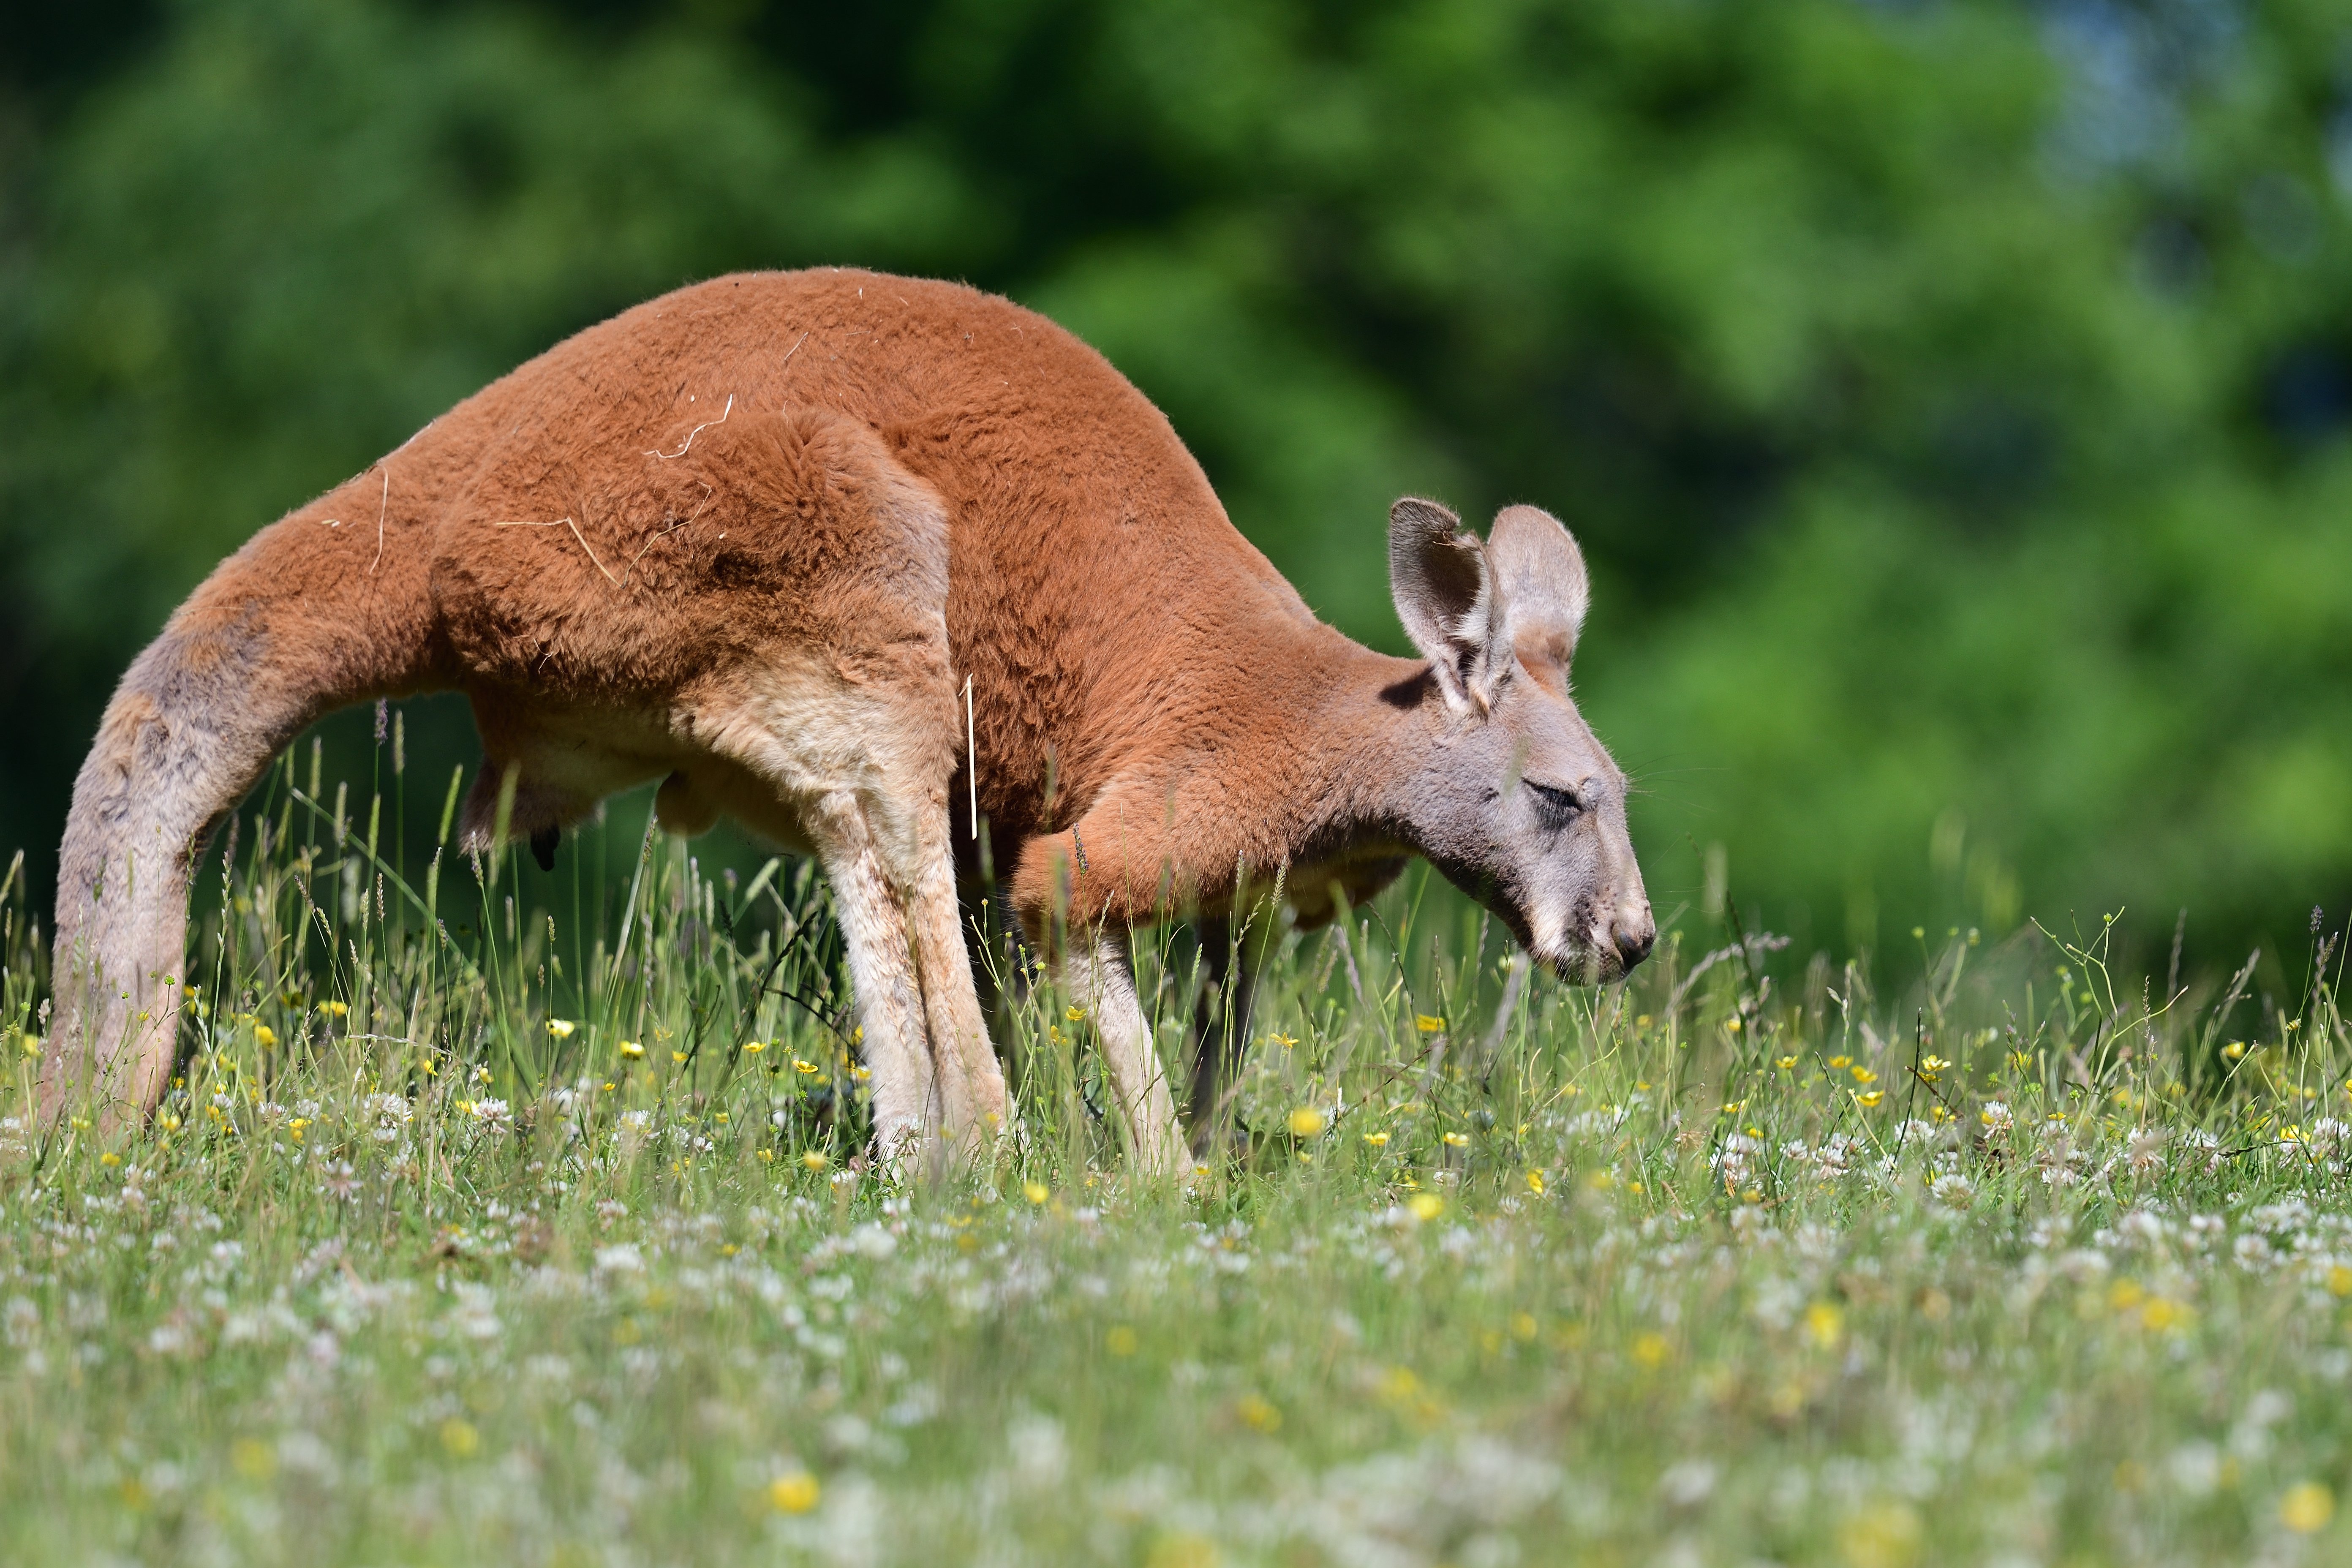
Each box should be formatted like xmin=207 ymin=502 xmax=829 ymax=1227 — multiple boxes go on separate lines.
xmin=0 ymin=0 xmax=2352 ymax=983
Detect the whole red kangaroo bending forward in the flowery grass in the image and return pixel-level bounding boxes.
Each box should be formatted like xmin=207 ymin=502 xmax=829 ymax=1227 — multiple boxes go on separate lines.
xmin=40 ymin=270 xmax=1656 ymax=1171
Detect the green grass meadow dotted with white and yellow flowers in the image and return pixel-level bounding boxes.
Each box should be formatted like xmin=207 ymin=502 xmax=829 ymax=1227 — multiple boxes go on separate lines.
xmin=0 ymin=764 xmax=2352 ymax=1568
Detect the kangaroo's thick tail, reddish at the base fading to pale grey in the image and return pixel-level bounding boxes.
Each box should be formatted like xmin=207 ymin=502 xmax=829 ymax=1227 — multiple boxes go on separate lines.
xmin=40 ymin=473 xmax=435 ymax=1122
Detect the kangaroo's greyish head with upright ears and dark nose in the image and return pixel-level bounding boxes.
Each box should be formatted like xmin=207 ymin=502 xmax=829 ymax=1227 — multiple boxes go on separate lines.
xmin=1388 ymin=498 xmax=1658 ymax=985
